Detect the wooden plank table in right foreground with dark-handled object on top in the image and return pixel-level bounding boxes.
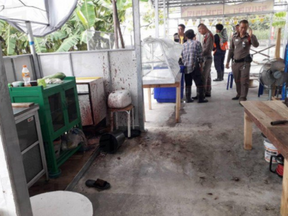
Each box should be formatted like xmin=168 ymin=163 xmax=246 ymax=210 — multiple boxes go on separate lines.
xmin=241 ymin=101 xmax=288 ymax=216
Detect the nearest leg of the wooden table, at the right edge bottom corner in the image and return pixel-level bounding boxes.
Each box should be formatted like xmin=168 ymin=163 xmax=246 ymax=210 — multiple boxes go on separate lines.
xmin=281 ymin=158 xmax=288 ymax=216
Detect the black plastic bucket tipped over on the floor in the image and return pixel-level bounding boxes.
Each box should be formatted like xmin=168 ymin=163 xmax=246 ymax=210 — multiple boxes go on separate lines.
xmin=99 ymin=130 xmax=125 ymax=153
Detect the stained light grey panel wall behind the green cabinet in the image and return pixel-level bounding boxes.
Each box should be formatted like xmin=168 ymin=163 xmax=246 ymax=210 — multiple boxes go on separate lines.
xmin=4 ymin=49 xmax=139 ymax=126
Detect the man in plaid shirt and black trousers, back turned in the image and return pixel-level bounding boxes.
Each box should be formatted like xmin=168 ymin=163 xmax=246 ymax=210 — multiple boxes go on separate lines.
xmin=181 ymin=29 xmax=208 ymax=103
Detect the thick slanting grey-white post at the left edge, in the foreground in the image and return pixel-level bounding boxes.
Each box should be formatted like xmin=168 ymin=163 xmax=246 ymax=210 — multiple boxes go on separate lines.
xmin=0 ymin=43 xmax=32 ymax=216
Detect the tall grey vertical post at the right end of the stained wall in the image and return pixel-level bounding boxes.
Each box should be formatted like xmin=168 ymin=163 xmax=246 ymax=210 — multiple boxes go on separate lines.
xmin=132 ymin=0 xmax=144 ymax=130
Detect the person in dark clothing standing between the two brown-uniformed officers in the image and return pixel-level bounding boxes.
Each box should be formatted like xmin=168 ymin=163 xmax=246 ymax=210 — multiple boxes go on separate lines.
xmin=213 ymin=24 xmax=226 ymax=81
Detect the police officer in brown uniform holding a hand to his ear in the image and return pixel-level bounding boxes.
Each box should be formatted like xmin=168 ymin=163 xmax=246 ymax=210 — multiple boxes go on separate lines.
xmin=226 ymin=20 xmax=259 ymax=105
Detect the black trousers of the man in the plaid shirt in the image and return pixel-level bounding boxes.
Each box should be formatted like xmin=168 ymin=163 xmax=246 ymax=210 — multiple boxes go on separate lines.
xmin=185 ymin=67 xmax=204 ymax=97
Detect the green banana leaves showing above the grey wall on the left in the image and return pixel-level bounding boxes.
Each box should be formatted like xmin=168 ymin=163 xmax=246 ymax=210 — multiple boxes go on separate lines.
xmin=0 ymin=0 xmax=134 ymax=55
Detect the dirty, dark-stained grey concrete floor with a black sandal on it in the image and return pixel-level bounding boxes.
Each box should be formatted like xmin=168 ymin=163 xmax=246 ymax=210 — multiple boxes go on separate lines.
xmin=75 ymin=72 xmax=282 ymax=216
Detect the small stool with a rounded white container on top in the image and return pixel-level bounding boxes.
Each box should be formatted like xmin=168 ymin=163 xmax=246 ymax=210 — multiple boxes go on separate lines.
xmin=109 ymin=104 xmax=134 ymax=137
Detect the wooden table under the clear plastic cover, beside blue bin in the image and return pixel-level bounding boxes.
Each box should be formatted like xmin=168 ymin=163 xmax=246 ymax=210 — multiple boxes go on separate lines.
xmin=143 ymin=82 xmax=181 ymax=123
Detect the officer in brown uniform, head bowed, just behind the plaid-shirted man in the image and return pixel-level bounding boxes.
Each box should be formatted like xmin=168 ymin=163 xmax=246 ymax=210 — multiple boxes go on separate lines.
xmin=194 ymin=23 xmax=214 ymax=99
